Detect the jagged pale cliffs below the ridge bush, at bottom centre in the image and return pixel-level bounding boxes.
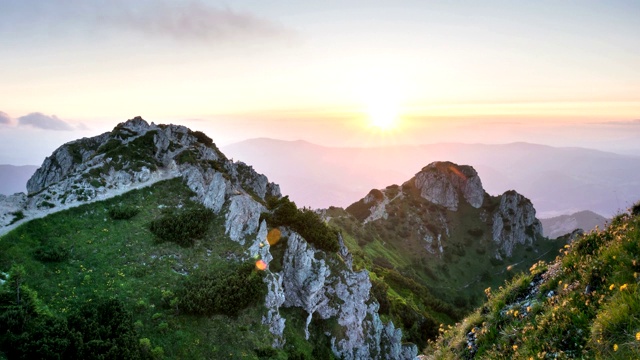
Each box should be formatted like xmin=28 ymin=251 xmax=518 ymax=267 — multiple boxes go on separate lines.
xmin=282 ymin=232 xmax=417 ymax=359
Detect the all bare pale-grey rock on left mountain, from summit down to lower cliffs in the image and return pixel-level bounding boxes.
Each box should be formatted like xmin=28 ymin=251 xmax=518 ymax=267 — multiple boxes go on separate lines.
xmin=0 ymin=117 xmax=417 ymax=359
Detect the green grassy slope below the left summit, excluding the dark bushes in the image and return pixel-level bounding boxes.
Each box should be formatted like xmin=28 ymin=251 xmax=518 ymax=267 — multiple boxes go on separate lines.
xmin=0 ymin=180 xmax=280 ymax=358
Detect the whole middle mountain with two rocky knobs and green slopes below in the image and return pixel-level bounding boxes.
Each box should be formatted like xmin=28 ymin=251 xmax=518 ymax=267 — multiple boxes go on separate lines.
xmin=323 ymin=162 xmax=566 ymax=346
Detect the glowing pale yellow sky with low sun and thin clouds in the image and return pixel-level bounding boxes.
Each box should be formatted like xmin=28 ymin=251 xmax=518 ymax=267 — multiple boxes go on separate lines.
xmin=0 ymin=0 xmax=640 ymax=165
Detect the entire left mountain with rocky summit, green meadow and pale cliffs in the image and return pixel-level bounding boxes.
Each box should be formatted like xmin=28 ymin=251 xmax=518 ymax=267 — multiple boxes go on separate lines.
xmin=0 ymin=118 xmax=417 ymax=359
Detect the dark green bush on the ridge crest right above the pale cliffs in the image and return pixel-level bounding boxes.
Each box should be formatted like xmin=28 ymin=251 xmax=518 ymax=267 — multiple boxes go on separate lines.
xmin=262 ymin=196 xmax=340 ymax=252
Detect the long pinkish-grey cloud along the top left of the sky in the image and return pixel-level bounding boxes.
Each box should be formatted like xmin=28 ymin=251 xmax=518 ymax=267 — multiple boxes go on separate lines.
xmin=0 ymin=0 xmax=290 ymax=42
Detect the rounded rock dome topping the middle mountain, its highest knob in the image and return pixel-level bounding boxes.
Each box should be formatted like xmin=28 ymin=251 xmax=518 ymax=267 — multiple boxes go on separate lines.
xmin=410 ymin=162 xmax=484 ymax=211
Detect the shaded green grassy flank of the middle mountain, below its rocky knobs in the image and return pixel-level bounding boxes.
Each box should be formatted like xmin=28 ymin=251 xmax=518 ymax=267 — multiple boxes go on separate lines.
xmin=327 ymin=185 xmax=565 ymax=345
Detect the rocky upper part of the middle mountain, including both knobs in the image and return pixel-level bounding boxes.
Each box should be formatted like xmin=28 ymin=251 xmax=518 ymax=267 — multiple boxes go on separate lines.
xmin=346 ymin=162 xmax=542 ymax=259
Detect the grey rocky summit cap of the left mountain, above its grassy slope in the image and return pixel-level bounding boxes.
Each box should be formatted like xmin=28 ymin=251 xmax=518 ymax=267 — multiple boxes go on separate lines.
xmin=0 ymin=117 xmax=281 ymax=236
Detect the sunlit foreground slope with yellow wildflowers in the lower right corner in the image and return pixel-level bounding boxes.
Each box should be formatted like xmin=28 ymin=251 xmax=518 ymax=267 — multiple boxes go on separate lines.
xmin=426 ymin=207 xmax=640 ymax=359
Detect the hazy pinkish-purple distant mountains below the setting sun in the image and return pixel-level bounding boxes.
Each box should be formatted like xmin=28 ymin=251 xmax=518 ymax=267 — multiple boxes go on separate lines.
xmin=222 ymin=138 xmax=640 ymax=218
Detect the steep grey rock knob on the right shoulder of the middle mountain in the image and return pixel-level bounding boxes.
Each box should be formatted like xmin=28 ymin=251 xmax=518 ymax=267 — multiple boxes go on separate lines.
xmin=493 ymin=191 xmax=542 ymax=257
